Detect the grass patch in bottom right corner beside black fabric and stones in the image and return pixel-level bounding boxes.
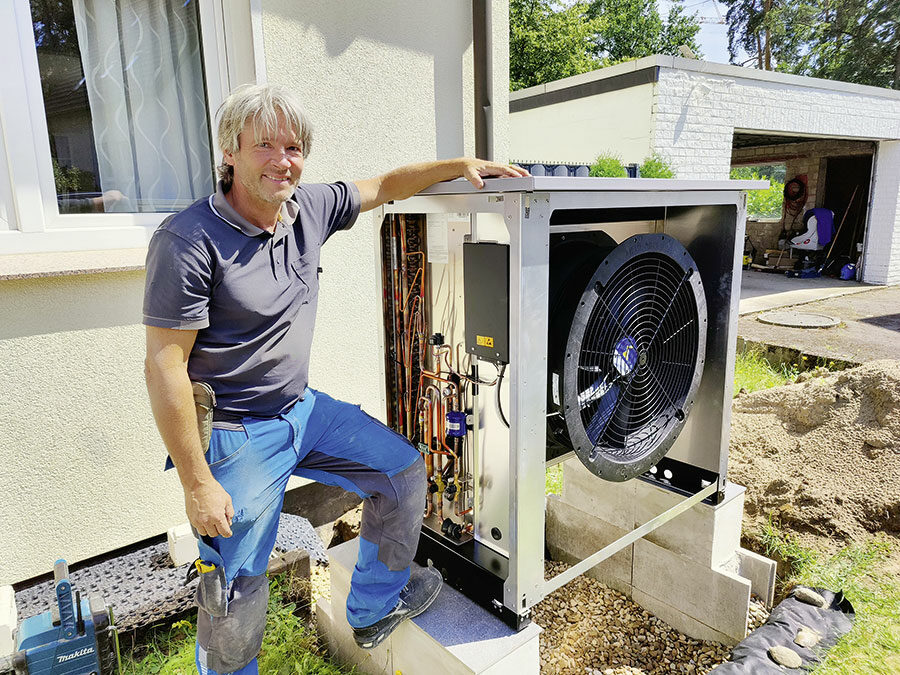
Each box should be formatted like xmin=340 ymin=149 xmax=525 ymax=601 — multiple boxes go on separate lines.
xmin=758 ymin=522 xmax=900 ymax=675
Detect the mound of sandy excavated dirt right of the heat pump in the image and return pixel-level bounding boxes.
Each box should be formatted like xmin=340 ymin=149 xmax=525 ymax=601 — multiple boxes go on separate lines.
xmin=728 ymin=360 xmax=900 ymax=551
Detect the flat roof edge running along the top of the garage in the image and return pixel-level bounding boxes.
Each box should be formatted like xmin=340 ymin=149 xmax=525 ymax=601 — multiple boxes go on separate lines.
xmin=509 ymin=54 xmax=900 ymax=112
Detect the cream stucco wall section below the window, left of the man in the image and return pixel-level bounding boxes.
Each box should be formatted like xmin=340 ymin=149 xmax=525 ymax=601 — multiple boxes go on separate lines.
xmin=0 ymin=271 xmax=184 ymax=584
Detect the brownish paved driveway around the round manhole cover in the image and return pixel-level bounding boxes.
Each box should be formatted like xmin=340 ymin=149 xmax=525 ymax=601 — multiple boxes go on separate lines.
xmin=738 ymin=286 xmax=900 ymax=365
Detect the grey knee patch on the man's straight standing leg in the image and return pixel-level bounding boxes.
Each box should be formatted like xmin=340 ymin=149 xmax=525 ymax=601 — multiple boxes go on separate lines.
xmin=197 ymin=574 xmax=269 ymax=673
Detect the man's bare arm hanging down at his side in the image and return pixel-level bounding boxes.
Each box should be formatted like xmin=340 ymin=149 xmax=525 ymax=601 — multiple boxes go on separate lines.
xmin=144 ymin=326 xmax=234 ymax=537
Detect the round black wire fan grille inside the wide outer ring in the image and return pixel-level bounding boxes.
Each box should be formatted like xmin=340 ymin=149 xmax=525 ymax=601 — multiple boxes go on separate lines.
xmin=576 ymin=253 xmax=699 ymax=461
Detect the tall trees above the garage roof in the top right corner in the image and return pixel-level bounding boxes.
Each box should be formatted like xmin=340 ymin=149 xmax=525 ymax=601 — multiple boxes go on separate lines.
xmin=722 ymin=0 xmax=900 ymax=89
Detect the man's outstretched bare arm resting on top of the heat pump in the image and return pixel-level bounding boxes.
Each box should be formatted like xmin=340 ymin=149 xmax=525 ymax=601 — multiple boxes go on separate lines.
xmin=356 ymin=157 xmax=528 ymax=211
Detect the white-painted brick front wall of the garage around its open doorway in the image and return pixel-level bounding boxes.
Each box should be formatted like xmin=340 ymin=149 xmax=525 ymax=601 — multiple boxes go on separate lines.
xmin=651 ymin=64 xmax=900 ymax=284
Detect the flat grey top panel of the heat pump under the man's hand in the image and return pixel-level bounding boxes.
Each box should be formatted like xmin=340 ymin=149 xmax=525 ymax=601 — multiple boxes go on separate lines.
xmin=419 ymin=176 xmax=769 ymax=195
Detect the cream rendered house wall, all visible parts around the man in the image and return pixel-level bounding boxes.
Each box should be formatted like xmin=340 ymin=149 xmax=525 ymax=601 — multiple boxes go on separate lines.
xmin=0 ymin=0 xmax=508 ymax=584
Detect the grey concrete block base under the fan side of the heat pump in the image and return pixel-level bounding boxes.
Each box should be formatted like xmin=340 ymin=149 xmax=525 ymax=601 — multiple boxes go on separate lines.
xmin=547 ymin=460 xmax=775 ymax=644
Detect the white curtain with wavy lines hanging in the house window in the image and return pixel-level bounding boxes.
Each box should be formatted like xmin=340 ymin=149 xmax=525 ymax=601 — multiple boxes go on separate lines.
xmin=73 ymin=0 xmax=213 ymax=211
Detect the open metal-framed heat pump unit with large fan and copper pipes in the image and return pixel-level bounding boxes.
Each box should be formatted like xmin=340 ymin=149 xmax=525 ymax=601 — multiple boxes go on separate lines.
xmin=379 ymin=177 xmax=764 ymax=627
